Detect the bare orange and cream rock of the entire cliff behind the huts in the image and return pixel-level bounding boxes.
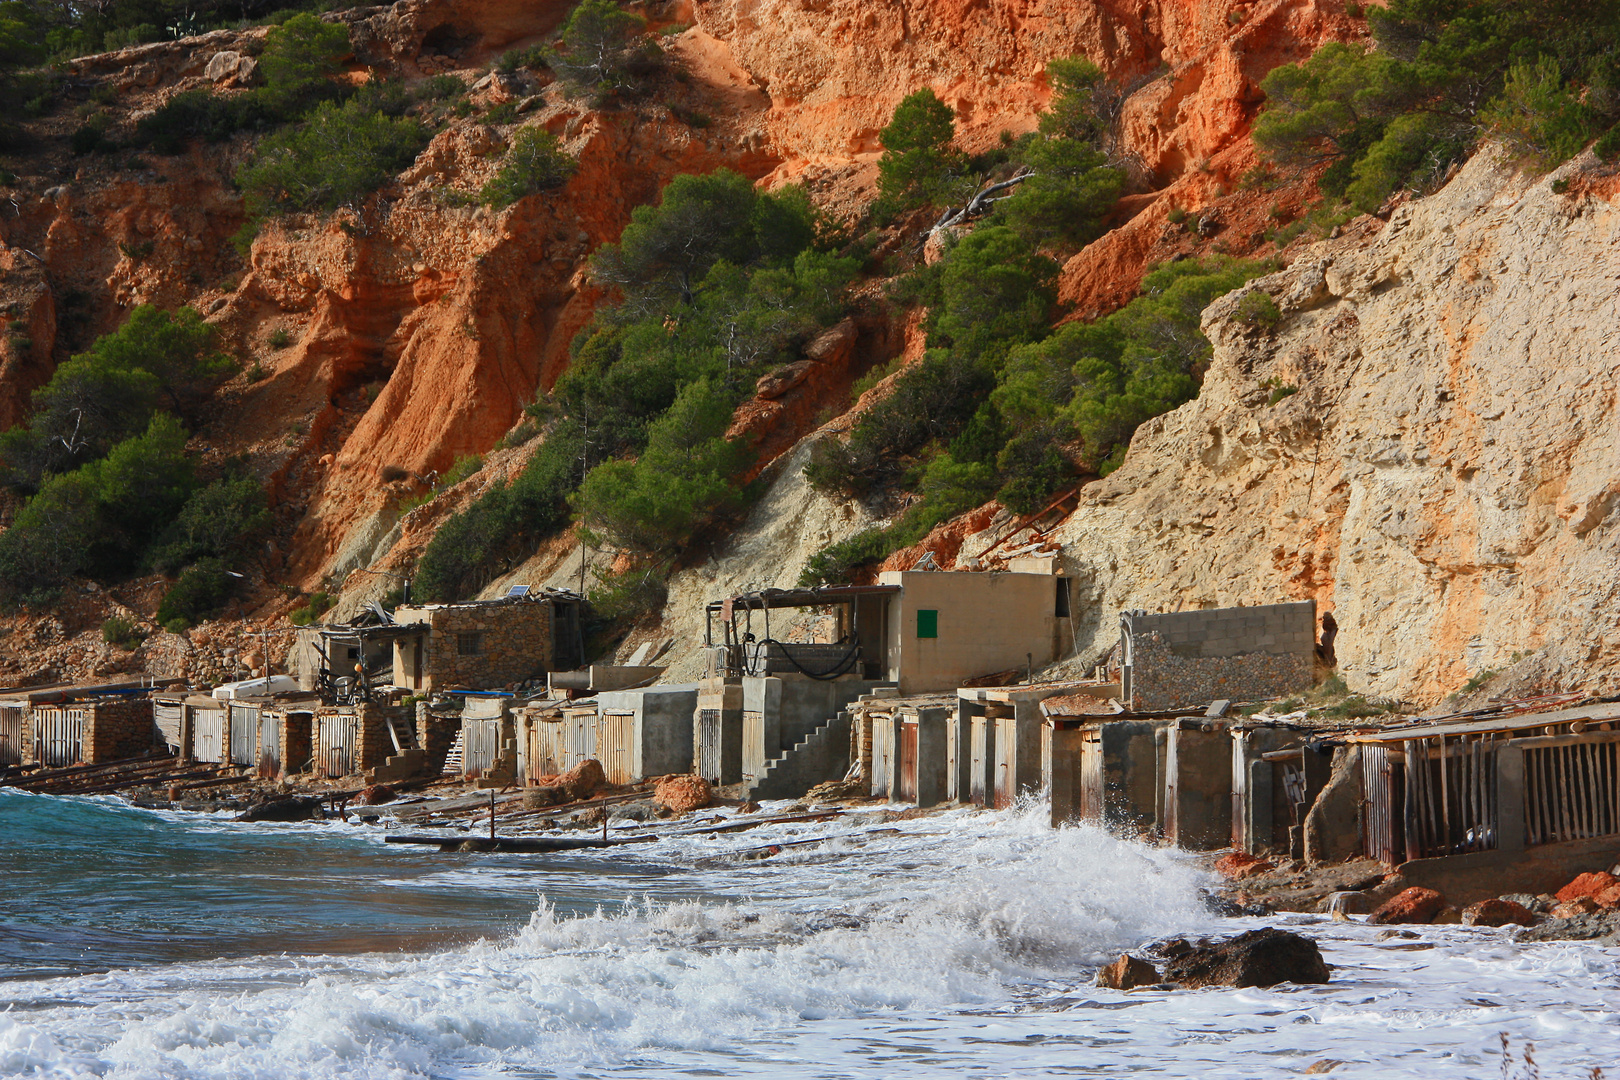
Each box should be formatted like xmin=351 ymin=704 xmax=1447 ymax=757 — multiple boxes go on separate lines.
xmin=19 ymin=0 xmax=1620 ymax=703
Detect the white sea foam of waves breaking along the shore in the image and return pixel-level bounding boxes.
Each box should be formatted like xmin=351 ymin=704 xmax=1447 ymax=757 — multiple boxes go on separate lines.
xmin=0 ymin=811 xmax=1620 ymax=1080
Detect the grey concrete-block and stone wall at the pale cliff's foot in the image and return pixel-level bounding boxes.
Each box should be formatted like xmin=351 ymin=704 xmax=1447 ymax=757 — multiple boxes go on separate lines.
xmin=1119 ymin=601 xmax=1315 ymax=712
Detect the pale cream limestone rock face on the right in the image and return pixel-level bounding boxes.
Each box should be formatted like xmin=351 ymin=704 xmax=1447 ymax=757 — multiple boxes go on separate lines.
xmin=1059 ymin=151 xmax=1620 ymax=704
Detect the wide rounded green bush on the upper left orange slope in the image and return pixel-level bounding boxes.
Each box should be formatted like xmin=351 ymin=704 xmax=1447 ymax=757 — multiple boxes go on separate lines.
xmin=237 ymin=100 xmax=428 ymax=217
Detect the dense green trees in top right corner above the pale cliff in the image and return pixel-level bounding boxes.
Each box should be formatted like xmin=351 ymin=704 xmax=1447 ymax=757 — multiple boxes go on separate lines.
xmin=1254 ymin=0 xmax=1620 ymax=212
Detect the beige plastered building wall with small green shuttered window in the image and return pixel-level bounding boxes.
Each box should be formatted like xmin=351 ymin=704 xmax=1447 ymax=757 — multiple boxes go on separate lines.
xmin=878 ymin=570 xmax=1066 ymax=695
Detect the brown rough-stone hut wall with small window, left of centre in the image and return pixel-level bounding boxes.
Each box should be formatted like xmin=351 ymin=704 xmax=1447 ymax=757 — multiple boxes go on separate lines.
xmin=394 ymin=601 xmax=552 ymax=693
